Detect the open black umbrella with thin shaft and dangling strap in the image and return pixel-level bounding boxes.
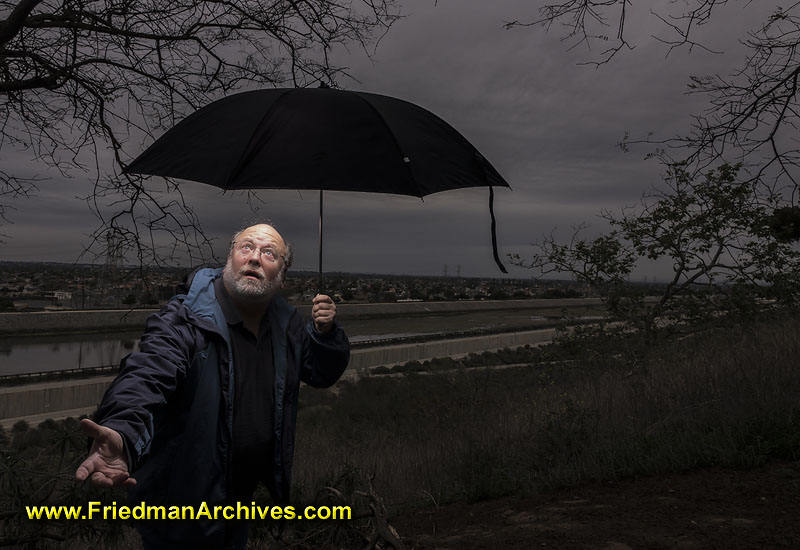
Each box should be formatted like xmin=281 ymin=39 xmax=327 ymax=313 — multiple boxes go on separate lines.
xmin=126 ymin=88 xmax=510 ymax=285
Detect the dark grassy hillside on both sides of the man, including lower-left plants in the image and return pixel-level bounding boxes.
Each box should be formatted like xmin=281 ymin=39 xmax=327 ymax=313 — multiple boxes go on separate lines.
xmin=0 ymin=318 xmax=800 ymax=549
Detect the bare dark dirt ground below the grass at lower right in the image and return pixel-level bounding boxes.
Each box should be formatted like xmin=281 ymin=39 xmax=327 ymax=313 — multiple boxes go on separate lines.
xmin=392 ymin=462 xmax=800 ymax=550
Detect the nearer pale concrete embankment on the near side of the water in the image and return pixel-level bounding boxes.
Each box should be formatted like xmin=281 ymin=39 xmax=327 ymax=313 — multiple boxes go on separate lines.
xmin=0 ymin=329 xmax=555 ymax=428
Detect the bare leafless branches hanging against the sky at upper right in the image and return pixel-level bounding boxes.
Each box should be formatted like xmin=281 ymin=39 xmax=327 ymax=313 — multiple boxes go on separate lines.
xmin=506 ymin=0 xmax=800 ymax=211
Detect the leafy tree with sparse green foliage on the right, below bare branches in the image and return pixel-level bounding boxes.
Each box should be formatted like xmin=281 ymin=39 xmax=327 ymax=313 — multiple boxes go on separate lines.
xmin=512 ymin=164 xmax=800 ymax=334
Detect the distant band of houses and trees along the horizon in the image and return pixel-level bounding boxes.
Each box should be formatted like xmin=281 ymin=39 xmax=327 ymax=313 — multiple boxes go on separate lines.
xmin=0 ymin=261 xmax=608 ymax=311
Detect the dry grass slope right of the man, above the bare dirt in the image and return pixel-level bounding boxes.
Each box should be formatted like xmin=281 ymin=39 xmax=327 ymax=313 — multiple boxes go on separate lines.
xmin=295 ymin=319 xmax=800 ymax=506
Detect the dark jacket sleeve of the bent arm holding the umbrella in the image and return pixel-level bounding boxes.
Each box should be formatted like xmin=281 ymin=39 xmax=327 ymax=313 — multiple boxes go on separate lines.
xmin=300 ymin=319 xmax=350 ymax=388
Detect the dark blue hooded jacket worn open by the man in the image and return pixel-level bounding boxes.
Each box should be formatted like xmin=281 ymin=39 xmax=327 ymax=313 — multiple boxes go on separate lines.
xmin=95 ymin=269 xmax=350 ymax=547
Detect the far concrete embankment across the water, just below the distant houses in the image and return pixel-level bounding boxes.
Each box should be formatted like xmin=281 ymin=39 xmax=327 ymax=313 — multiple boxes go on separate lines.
xmin=0 ymin=298 xmax=602 ymax=336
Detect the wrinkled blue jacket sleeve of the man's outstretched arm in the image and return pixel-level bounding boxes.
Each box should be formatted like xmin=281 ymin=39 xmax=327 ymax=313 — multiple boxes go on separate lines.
xmin=95 ymin=300 xmax=196 ymax=471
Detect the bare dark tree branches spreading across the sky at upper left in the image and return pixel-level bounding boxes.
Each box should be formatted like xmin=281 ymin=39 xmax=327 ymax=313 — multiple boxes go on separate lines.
xmin=0 ymin=0 xmax=398 ymax=264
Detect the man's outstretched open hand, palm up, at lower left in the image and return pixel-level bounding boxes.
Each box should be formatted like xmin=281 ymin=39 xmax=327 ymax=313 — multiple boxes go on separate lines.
xmin=75 ymin=418 xmax=136 ymax=487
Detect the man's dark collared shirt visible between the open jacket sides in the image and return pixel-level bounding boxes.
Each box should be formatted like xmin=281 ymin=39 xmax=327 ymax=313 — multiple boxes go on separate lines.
xmin=214 ymin=278 xmax=275 ymax=502
